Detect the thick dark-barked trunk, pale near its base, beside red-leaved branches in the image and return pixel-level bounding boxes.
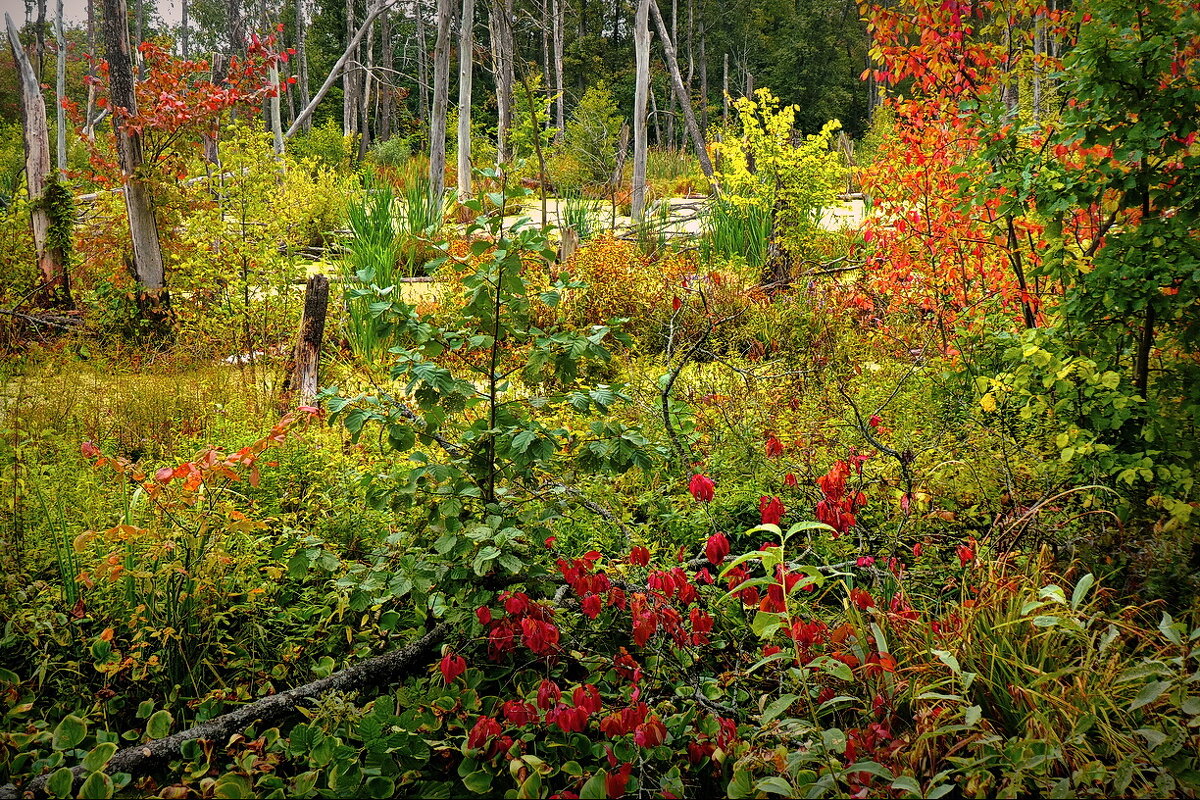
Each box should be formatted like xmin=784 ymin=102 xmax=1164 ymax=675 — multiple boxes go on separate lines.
xmin=104 ymin=0 xmax=167 ymax=315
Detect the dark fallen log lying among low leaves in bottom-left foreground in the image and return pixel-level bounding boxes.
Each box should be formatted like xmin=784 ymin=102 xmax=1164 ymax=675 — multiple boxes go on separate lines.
xmin=0 ymin=622 xmax=450 ymax=800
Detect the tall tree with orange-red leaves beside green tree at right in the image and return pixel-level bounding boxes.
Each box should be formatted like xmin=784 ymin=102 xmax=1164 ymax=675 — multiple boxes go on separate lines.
xmin=862 ymin=0 xmax=1057 ymax=345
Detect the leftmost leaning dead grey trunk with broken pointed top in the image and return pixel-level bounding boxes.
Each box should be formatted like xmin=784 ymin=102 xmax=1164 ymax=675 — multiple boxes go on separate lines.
xmin=4 ymin=13 xmax=71 ymax=307
